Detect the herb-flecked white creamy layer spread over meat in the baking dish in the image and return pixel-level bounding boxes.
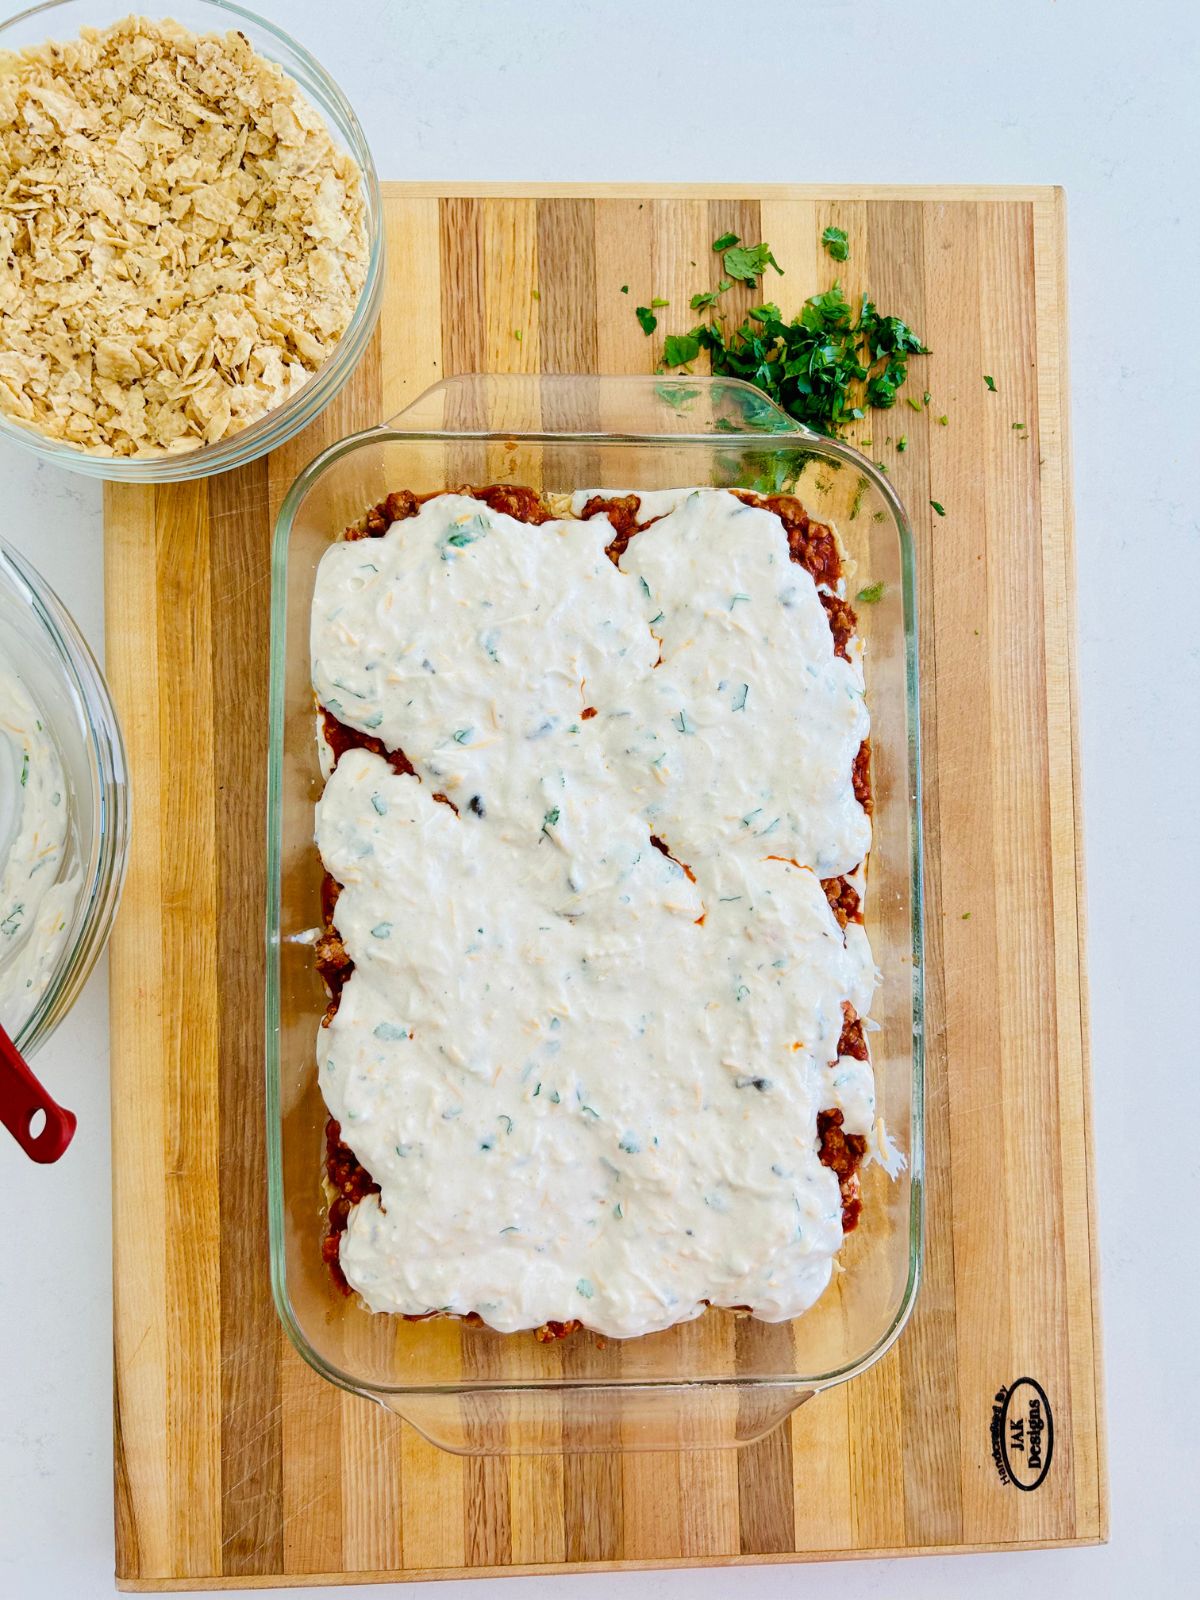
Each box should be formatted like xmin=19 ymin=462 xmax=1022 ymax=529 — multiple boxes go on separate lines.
xmin=312 ymin=490 xmax=875 ymax=1338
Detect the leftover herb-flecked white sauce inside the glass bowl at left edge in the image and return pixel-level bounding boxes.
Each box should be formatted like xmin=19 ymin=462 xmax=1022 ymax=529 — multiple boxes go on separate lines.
xmin=0 ymin=664 xmax=80 ymax=1035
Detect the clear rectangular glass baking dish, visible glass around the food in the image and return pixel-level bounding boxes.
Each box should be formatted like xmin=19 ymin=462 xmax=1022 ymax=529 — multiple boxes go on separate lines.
xmin=266 ymin=376 xmax=923 ymax=1454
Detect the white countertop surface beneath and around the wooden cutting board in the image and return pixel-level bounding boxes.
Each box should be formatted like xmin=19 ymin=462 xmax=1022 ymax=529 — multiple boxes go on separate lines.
xmin=0 ymin=0 xmax=1200 ymax=1600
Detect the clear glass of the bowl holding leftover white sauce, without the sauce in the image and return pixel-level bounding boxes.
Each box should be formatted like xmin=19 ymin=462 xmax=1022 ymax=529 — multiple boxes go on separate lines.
xmin=0 ymin=539 xmax=130 ymax=1058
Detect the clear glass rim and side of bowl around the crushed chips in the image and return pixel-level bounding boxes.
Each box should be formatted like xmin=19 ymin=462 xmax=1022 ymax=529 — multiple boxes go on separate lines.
xmin=0 ymin=0 xmax=384 ymax=483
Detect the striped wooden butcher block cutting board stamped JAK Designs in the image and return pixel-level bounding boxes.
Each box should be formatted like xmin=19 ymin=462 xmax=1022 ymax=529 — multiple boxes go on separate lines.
xmin=106 ymin=184 xmax=1107 ymax=1589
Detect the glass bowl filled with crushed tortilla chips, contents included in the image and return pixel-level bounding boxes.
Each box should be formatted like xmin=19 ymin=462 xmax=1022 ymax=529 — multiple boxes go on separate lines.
xmin=0 ymin=0 xmax=384 ymax=483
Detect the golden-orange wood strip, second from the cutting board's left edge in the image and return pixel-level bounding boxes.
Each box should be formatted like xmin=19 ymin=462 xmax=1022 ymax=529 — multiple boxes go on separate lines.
xmin=155 ymin=482 xmax=221 ymax=1578
